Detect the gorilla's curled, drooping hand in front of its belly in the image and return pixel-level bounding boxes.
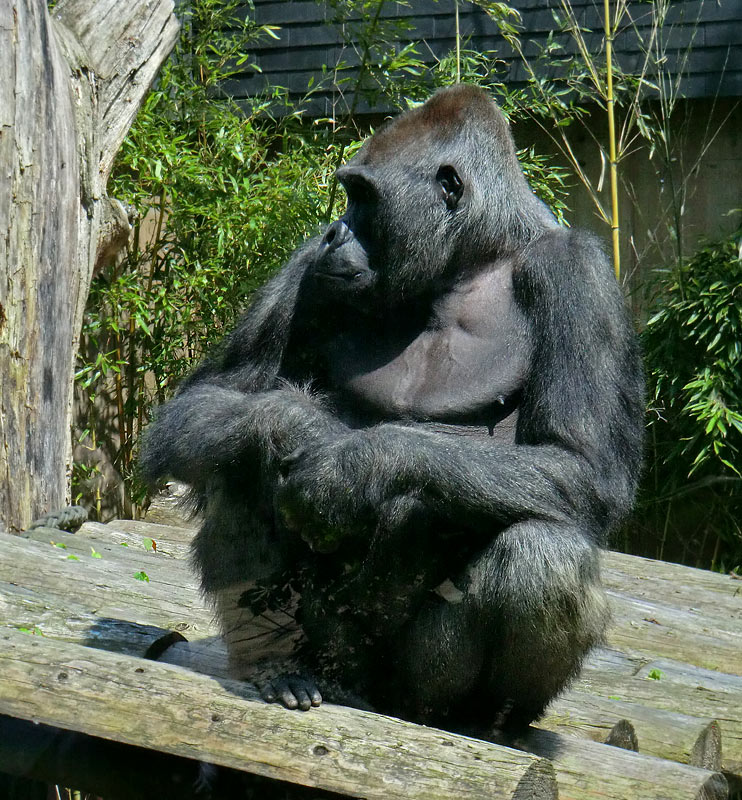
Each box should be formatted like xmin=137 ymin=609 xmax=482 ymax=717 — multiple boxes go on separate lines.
xmin=276 ymin=431 xmax=391 ymax=553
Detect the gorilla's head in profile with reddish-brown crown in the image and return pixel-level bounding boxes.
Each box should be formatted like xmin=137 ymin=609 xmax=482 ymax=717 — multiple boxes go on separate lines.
xmin=315 ymin=85 xmax=555 ymax=304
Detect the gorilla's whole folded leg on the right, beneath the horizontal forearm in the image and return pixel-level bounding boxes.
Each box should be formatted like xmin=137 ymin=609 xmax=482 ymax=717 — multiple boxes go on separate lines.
xmin=403 ymin=521 xmax=607 ymax=731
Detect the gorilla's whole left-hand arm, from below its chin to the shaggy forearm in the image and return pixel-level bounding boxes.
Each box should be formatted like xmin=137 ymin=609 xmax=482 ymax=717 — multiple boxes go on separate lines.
xmin=140 ymin=240 xmax=344 ymax=487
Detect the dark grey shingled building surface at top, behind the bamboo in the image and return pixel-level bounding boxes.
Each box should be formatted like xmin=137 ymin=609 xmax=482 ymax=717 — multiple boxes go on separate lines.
xmin=235 ymin=0 xmax=742 ymax=115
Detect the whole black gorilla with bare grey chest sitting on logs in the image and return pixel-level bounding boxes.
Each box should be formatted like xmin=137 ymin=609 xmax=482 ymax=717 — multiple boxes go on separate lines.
xmin=142 ymin=85 xmax=643 ymax=731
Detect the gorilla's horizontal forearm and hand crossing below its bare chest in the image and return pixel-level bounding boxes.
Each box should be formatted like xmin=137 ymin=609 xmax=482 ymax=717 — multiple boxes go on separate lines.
xmin=278 ymin=423 xmax=632 ymax=550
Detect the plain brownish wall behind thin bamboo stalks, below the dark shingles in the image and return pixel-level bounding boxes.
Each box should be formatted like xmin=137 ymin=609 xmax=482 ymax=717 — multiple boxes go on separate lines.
xmin=513 ymin=99 xmax=742 ymax=316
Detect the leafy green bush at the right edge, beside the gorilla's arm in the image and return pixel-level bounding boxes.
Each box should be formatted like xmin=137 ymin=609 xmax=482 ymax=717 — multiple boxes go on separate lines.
xmin=643 ymin=231 xmax=742 ymax=563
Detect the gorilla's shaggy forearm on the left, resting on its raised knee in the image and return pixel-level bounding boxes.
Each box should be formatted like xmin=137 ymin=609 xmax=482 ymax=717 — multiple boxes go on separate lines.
xmin=141 ymin=383 xmax=345 ymax=485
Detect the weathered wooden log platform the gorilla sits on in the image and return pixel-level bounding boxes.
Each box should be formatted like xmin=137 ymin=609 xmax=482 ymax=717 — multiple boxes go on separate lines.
xmin=0 ymin=520 xmax=742 ymax=800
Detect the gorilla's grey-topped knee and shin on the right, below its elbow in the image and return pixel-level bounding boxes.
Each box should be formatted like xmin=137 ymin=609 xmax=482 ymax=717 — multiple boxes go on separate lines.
xmin=471 ymin=522 xmax=608 ymax=725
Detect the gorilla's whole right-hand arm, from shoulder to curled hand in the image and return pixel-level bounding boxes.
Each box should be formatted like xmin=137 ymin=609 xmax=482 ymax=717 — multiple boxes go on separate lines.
xmin=279 ymin=230 xmax=643 ymax=549
